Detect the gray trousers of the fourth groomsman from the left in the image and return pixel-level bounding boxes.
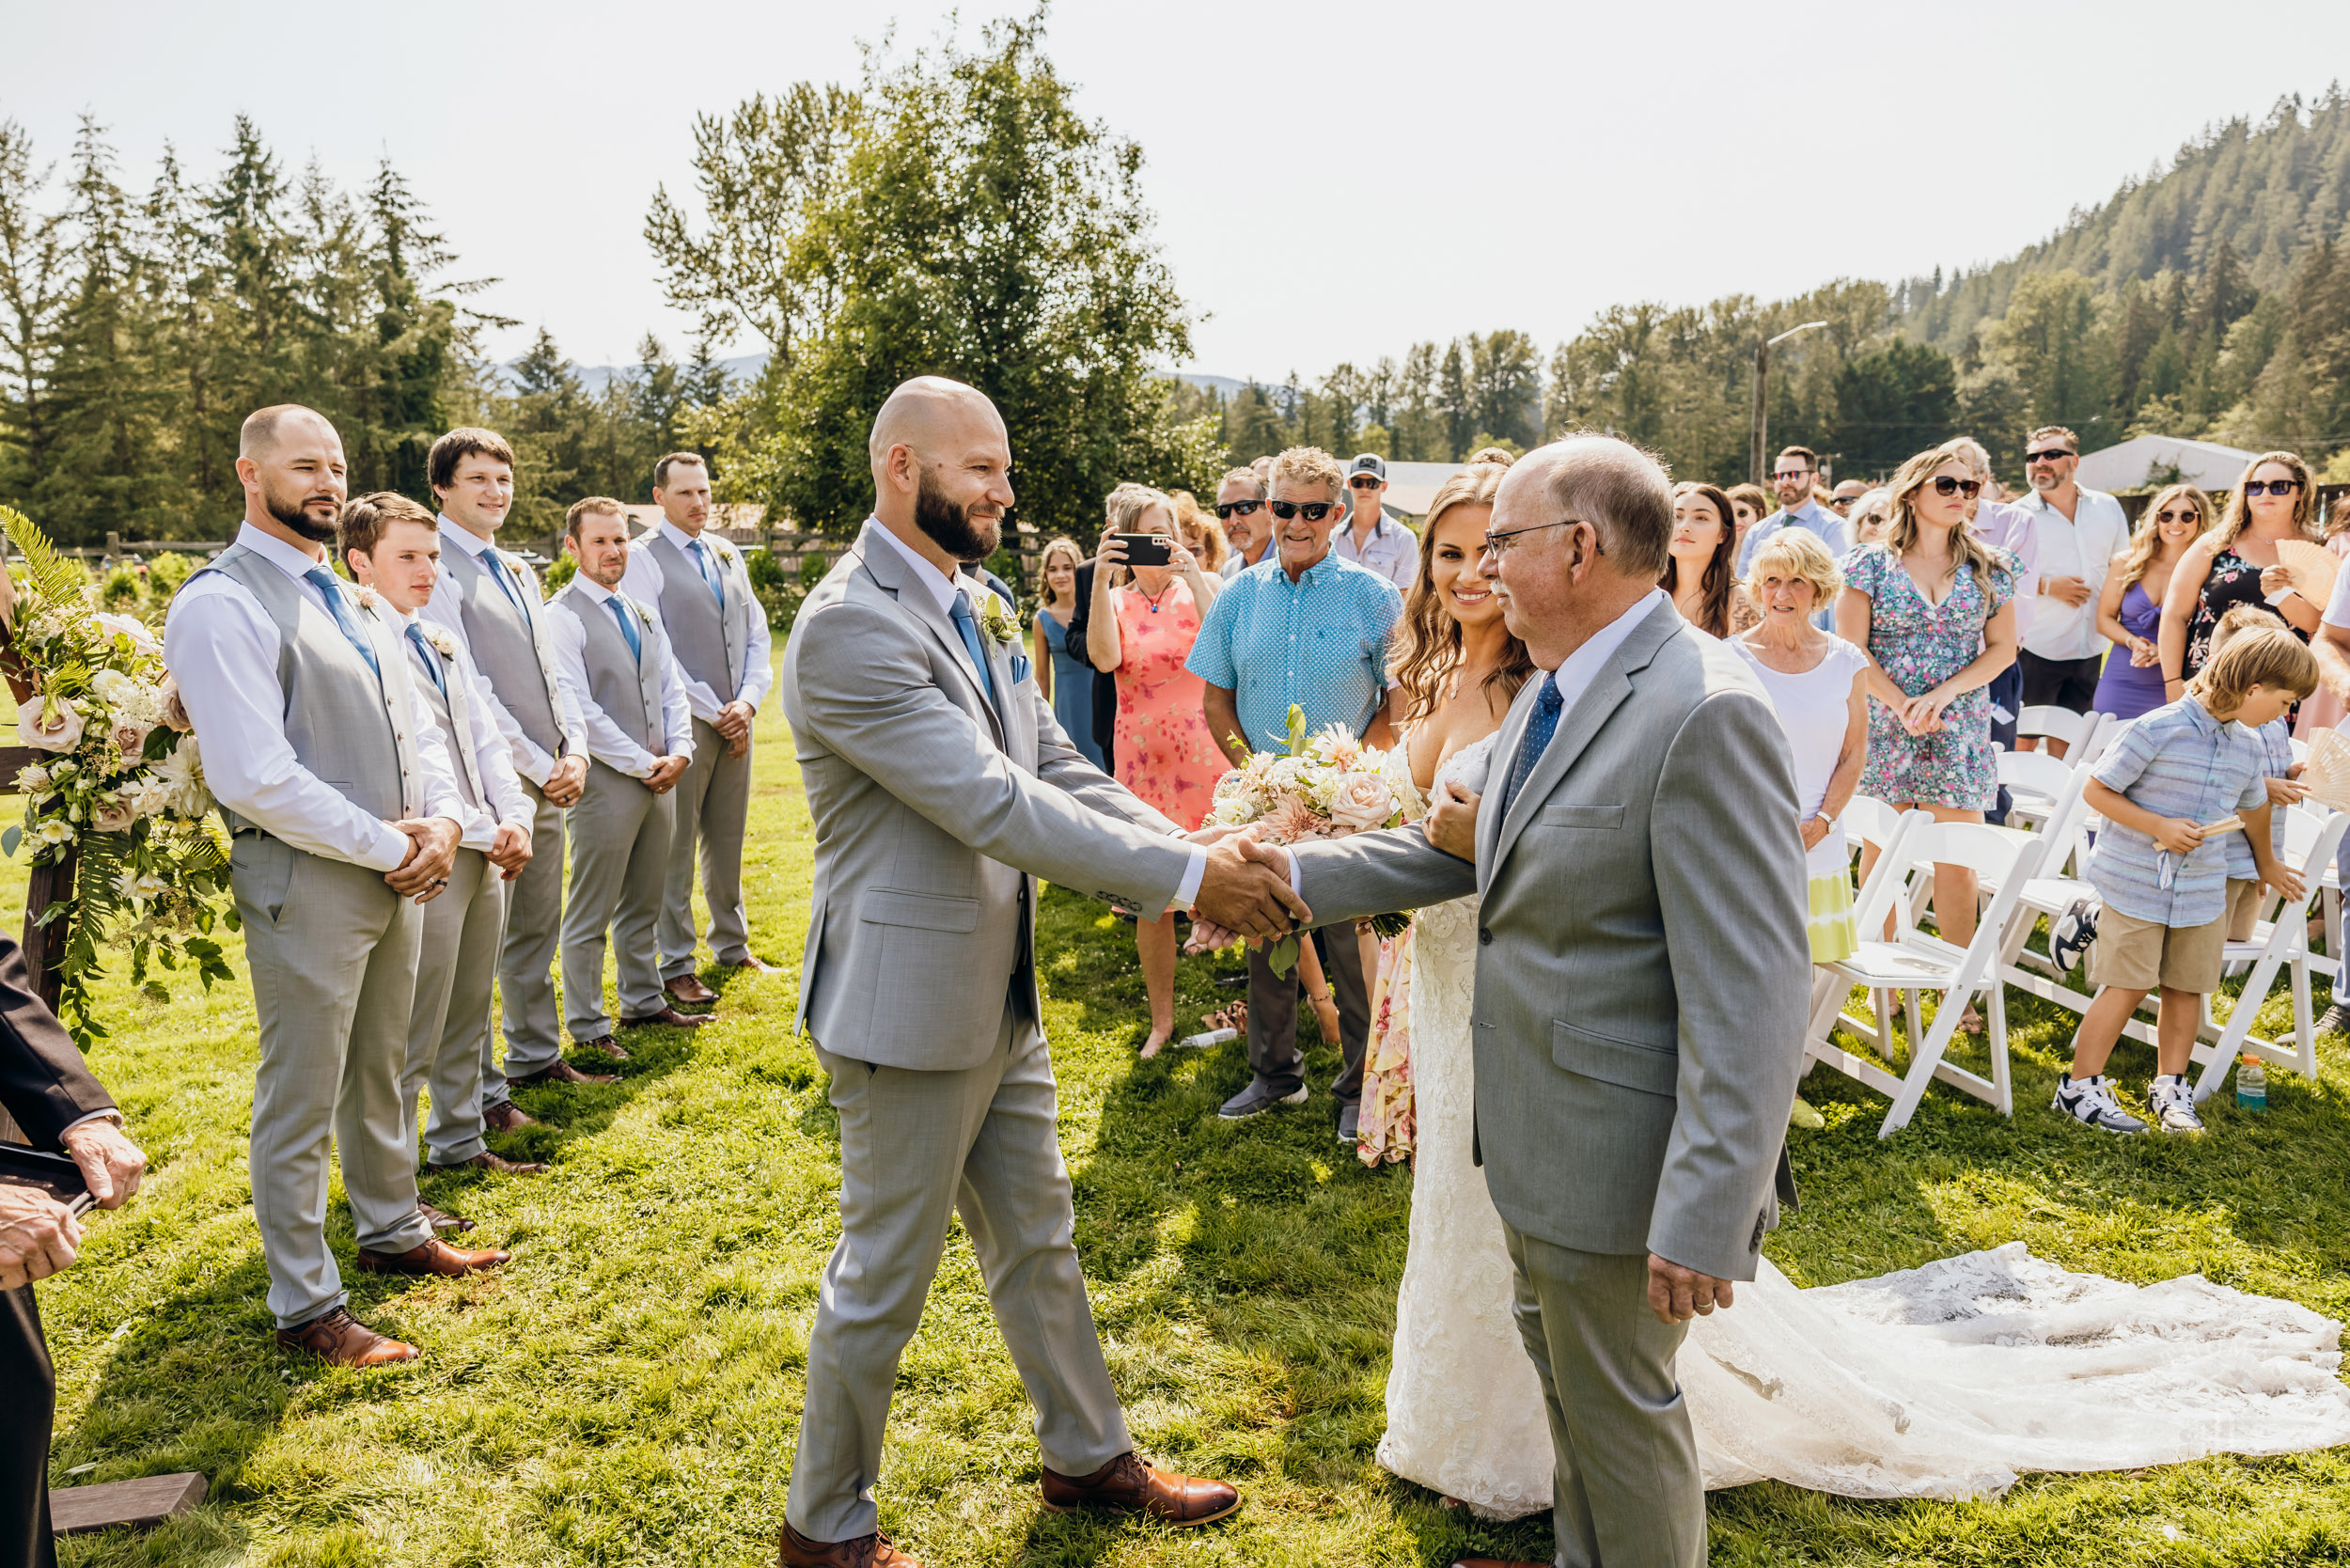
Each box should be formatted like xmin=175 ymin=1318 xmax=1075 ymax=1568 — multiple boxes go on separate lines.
xmin=564 ymin=761 xmax=675 ymax=1039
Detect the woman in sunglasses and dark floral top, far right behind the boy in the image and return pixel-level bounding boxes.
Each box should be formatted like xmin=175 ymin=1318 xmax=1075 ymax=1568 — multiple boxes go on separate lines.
xmin=2157 ymin=451 xmax=2325 ymax=703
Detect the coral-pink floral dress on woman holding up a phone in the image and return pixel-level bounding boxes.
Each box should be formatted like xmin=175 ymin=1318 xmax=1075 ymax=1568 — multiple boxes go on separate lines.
xmin=1109 ymin=578 xmax=1225 ymax=827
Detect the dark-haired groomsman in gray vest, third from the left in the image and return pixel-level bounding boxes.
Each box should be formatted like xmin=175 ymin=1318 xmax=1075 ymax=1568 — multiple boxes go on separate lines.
xmin=423 ymin=428 xmax=588 ymax=1109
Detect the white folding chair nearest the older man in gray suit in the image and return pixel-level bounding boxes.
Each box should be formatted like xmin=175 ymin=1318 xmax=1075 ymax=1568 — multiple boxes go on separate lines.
xmin=1805 ymin=821 xmax=2047 ymax=1137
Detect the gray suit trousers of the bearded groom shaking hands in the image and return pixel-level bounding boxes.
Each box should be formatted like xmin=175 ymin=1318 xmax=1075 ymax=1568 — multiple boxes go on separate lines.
xmin=785 ymin=1006 xmax=1133 ymax=1540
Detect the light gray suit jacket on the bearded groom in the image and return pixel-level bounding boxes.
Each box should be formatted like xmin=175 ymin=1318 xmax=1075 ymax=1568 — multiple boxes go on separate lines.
xmin=778 ymin=522 xmax=1192 ymax=1072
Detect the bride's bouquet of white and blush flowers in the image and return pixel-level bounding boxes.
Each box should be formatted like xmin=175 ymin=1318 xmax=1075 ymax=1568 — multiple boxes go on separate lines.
xmin=1206 ymin=703 xmax=1427 ymax=973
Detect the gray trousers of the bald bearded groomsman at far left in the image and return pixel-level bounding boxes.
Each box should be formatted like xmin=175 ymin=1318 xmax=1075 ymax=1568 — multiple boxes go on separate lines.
xmin=228 ymin=832 xmax=432 ymax=1328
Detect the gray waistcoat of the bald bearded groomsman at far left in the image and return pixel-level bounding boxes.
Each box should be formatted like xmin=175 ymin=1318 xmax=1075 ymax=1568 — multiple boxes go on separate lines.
xmin=196 ymin=545 xmax=420 ymax=832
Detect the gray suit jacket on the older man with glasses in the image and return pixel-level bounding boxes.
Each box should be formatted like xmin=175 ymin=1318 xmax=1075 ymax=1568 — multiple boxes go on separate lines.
xmin=1292 ymin=604 xmax=1812 ymax=1278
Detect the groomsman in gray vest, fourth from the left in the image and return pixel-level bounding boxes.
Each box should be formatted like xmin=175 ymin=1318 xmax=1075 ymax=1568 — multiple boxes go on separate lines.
xmin=548 ymin=496 xmax=710 ymax=1062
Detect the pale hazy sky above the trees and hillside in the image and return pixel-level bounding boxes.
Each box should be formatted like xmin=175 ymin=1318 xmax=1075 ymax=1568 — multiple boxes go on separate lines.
xmin=0 ymin=0 xmax=2350 ymax=379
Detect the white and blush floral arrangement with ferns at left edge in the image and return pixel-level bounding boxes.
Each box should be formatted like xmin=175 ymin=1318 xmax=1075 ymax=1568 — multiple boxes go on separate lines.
xmin=0 ymin=508 xmax=238 ymax=1051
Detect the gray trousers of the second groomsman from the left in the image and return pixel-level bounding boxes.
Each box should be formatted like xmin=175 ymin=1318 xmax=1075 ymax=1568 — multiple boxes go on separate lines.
xmin=400 ymin=849 xmax=506 ymax=1166
